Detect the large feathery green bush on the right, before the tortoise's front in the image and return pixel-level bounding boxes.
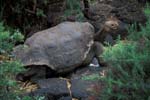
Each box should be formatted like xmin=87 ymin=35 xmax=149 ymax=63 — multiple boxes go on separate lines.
xmin=100 ymin=5 xmax=150 ymax=100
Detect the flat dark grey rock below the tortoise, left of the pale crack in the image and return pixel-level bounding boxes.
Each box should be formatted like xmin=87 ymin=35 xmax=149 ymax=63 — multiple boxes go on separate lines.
xmin=28 ymin=78 xmax=71 ymax=100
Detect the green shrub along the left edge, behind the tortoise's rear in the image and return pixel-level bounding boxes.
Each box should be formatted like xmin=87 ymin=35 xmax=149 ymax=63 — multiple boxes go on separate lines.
xmin=0 ymin=22 xmax=23 ymax=100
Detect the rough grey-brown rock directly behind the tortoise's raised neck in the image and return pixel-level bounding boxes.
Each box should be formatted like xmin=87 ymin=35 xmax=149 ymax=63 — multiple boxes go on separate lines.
xmin=85 ymin=3 xmax=113 ymax=31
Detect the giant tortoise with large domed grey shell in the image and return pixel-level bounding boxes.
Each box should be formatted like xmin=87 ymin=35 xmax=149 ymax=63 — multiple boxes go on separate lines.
xmin=13 ymin=19 xmax=126 ymax=81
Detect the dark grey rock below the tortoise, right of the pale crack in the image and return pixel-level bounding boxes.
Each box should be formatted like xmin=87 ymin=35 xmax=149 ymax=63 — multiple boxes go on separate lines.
xmin=71 ymin=79 xmax=102 ymax=100
